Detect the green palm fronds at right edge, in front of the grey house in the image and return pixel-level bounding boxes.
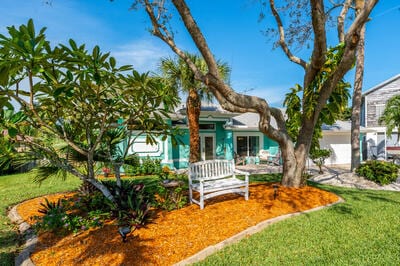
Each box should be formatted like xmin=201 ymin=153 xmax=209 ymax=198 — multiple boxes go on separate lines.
xmin=379 ymin=95 xmax=400 ymax=143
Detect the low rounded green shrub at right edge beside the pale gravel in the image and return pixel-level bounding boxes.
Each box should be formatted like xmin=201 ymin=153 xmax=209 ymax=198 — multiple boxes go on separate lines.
xmin=356 ymin=160 xmax=400 ymax=185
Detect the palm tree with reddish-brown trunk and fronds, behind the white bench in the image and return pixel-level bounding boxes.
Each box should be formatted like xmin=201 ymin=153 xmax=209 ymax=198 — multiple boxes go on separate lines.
xmin=160 ymin=53 xmax=230 ymax=163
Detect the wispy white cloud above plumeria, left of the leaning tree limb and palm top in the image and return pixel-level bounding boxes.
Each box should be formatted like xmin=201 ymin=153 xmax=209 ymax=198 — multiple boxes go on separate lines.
xmin=112 ymin=40 xmax=172 ymax=72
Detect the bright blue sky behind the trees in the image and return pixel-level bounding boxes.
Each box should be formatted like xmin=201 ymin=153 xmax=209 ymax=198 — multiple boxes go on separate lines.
xmin=0 ymin=0 xmax=400 ymax=107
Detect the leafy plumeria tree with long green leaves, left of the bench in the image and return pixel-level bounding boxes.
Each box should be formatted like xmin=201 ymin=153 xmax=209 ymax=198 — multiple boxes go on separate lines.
xmin=0 ymin=20 xmax=178 ymax=200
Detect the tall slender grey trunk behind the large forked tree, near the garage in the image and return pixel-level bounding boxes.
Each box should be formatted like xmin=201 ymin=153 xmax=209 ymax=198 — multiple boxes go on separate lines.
xmin=351 ymin=0 xmax=365 ymax=171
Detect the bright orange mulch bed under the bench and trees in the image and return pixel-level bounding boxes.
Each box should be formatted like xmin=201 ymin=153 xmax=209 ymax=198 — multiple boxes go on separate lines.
xmin=18 ymin=183 xmax=339 ymax=266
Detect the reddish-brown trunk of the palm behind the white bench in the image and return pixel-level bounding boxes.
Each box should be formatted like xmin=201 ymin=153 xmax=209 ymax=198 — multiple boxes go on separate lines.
xmin=186 ymin=88 xmax=201 ymax=163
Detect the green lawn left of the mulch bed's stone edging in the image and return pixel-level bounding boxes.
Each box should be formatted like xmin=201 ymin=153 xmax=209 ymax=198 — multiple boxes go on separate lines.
xmin=0 ymin=173 xmax=81 ymax=265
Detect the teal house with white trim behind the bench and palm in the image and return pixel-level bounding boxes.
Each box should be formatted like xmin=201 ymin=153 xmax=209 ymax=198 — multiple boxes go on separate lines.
xmin=125 ymin=105 xmax=279 ymax=169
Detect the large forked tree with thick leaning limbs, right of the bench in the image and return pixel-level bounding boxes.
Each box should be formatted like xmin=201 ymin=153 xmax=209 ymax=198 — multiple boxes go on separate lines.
xmin=134 ymin=0 xmax=378 ymax=187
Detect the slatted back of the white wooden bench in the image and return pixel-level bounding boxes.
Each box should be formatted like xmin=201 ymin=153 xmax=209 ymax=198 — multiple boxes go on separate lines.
xmin=189 ymin=160 xmax=235 ymax=180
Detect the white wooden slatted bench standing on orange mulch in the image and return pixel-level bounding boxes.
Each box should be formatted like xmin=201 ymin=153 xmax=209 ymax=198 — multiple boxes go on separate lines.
xmin=188 ymin=160 xmax=249 ymax=209
